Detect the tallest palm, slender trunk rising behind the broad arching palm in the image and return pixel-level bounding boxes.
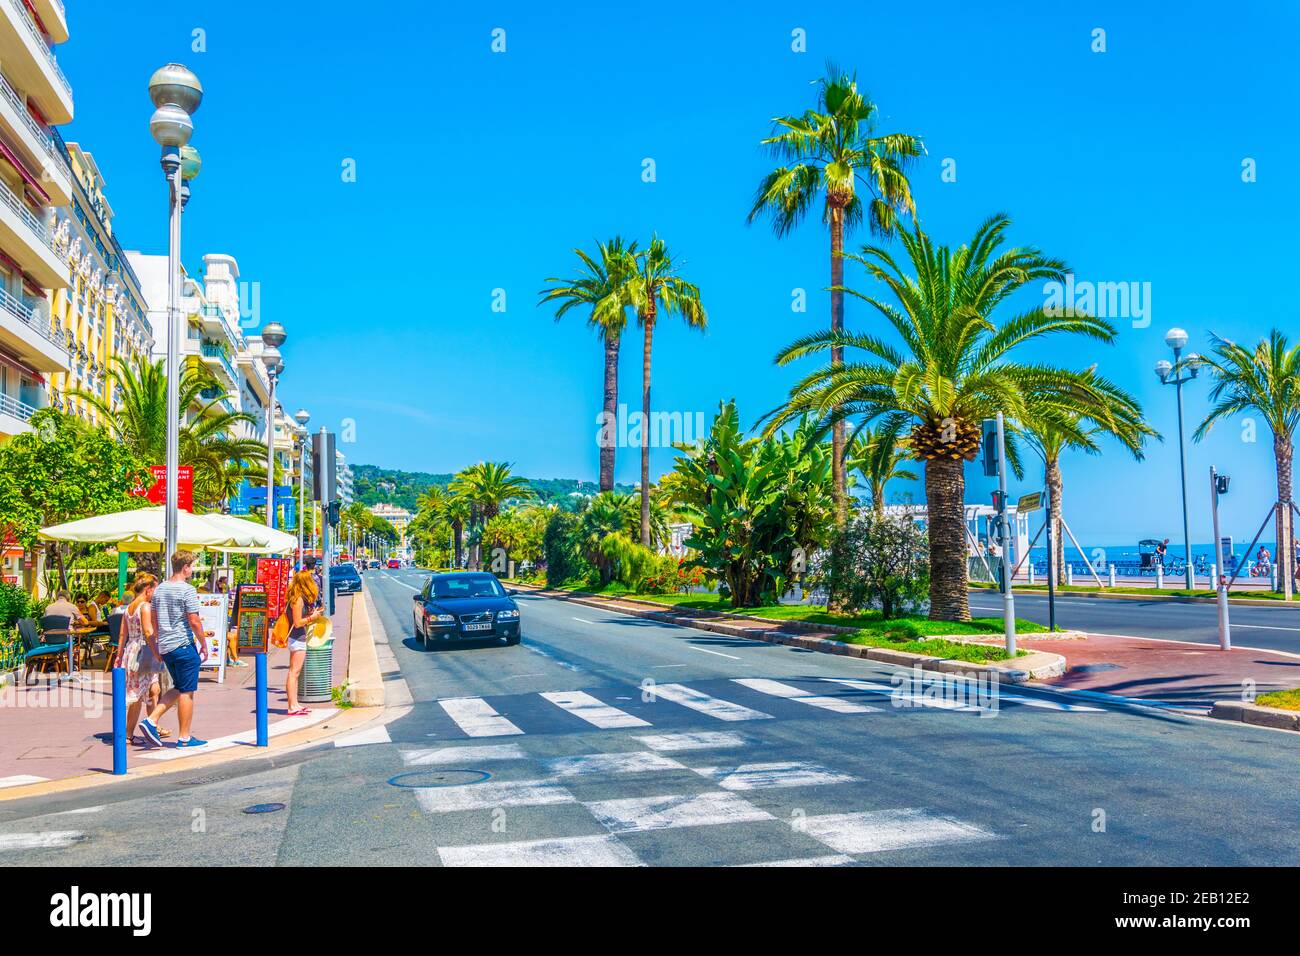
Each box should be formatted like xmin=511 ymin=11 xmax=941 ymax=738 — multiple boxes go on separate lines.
xmin=748 ymin=64 xmax=924 ymax=524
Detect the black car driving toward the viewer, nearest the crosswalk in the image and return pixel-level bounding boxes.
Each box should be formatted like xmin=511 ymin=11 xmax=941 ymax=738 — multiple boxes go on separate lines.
xmin=415 ymin=571 xmax=520 ymax=648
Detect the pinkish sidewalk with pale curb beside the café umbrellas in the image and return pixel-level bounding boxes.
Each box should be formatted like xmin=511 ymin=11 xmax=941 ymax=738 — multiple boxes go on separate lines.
xmin=0 ymin=594 xmax=364 ymax=792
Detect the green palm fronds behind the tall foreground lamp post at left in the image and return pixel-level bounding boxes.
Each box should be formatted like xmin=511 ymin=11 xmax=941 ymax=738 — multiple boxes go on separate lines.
xmin=70 ymin=355 xmax=267 ymax=505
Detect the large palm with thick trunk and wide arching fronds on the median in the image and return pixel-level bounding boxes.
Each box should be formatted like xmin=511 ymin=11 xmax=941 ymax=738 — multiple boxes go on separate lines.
xmin=768 ymin=216 xmax=1118 ymax=620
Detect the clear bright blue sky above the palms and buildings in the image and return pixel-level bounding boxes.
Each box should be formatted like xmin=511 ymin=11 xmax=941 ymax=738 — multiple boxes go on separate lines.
xmin=60 ymin=0 xmax=1300 ymax=544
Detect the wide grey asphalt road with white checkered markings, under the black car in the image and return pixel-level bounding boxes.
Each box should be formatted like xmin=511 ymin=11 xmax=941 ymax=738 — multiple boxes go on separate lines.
xmin=0 ymin=571 xmax=1300 ymax=866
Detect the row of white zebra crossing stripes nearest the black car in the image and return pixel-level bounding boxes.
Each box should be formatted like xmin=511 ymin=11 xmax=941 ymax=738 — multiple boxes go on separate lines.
xmin=436 ymin=678 xmax=1102 ymax=737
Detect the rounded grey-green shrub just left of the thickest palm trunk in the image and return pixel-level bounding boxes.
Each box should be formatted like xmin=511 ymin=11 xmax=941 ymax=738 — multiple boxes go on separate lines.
xmin=814 ymin=509 xmax=930 ymax=619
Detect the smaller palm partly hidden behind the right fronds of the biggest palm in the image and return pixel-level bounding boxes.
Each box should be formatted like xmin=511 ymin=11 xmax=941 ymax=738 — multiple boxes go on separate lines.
xmin=1021 ymin=403 xmax=1160 ymax=585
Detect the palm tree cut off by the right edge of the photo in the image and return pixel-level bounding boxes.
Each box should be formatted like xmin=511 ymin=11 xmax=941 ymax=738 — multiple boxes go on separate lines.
xmin=1192 ymin=329 xmax=1300 ymax=595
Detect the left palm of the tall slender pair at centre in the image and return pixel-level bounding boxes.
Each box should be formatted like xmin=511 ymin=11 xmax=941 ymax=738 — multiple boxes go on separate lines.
xmin=541 ymin=235 xmax=637 ymax=492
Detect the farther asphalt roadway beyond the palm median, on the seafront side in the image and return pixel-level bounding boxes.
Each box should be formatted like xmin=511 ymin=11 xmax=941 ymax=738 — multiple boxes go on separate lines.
xmin=971 ymin=591 xmax=1300 ymax=653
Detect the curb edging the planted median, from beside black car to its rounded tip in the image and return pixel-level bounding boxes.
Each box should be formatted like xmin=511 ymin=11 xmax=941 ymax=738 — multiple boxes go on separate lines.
xmin=512 ymin=584 xmax=1066 ymax=684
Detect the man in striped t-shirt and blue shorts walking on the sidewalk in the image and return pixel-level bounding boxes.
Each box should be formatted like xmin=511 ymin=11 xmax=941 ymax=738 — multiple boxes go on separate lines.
xmin=140 ymin=551 xmax=211 ymax=747
